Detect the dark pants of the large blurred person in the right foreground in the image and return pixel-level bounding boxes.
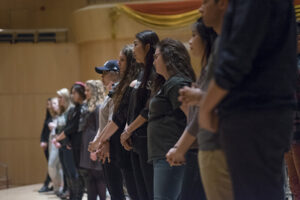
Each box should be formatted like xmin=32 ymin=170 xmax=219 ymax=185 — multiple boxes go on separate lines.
xmin=220 ymin=110 xmax=293 ymax=200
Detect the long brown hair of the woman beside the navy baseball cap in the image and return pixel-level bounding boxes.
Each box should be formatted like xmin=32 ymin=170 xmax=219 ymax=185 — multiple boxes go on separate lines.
xmin=113 ymin=45 xmax=141 ymax=112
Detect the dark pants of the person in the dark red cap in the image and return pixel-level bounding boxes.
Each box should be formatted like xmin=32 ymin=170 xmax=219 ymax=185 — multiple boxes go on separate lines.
xmin=59 ymin=146 xmax=84 ymax=200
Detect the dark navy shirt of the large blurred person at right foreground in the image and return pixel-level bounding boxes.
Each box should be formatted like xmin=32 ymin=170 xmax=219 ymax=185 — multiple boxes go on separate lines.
xmin=215 ymin=0 xmax=297 ymax=116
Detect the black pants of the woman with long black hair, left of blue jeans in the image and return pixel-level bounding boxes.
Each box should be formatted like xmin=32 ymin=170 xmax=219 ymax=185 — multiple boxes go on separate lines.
xmin=131 ymin=136 xmax=153 ymax=200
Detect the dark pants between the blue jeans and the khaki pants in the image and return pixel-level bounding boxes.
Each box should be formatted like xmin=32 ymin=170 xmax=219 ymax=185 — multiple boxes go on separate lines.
xmin=180 ymin=149 xmax=206 ymax=200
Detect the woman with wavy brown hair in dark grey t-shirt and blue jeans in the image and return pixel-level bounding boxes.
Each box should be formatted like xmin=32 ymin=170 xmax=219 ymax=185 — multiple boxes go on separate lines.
xmin=148 ymin=38 xmax=195 ymax=200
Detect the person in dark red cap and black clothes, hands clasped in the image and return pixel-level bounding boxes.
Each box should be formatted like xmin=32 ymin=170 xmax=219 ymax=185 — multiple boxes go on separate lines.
xmin=53 ymin=82 xmax=85 ymax=200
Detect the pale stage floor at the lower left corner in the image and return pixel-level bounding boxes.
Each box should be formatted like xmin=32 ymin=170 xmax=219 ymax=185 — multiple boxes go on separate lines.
xmin=0 ymin=184 xmax=87 ymax=200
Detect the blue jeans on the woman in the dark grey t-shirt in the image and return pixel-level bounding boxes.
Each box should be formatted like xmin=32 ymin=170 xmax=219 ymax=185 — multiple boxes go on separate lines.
xmin=153 ymin=159 xmax=185 ymax=200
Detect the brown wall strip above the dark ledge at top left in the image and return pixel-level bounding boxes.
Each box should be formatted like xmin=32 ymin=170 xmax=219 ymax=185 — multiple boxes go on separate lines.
xmin=0 ymin=0 xmax=87 ymax=41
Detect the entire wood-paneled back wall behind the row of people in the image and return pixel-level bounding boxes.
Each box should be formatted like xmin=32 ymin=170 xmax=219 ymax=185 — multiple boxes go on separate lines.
xmin=0 ymin=0 xmax=200 ymax=185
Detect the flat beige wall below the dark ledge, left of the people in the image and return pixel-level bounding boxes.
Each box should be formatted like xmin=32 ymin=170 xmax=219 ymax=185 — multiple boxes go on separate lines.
xmin=0 ymin=43 xmax=79 ymax=185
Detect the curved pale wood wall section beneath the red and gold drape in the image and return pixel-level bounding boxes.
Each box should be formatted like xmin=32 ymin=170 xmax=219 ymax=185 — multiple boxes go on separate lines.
xmin=73 ymin=4 xmax=200 ymax=80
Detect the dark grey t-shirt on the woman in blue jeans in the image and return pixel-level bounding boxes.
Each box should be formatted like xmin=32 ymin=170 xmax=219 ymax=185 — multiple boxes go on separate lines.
xmin=148 ymin=76 xmax=191 ymax=161
